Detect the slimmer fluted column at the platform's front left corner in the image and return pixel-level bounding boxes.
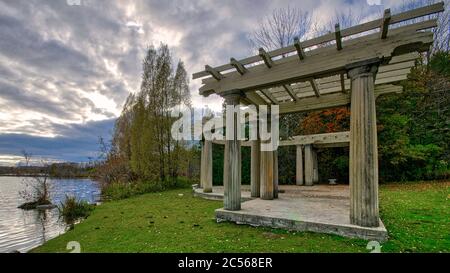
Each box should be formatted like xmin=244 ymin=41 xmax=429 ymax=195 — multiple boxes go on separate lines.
xmin=222 ymin=90 xmax=242 ymax=211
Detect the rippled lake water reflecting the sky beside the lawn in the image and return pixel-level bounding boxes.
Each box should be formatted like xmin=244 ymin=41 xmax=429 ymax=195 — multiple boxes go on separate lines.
xmin=0 ymin=177 xmax=100 ymax=253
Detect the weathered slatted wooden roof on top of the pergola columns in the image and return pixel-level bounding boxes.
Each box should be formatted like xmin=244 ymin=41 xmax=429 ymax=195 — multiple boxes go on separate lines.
xmin=193 ymin=2 xmax=444 ymax=113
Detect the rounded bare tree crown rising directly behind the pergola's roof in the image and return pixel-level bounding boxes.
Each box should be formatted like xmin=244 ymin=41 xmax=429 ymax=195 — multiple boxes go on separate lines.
xmin=249 ymin=6 xmax=312 ymax=50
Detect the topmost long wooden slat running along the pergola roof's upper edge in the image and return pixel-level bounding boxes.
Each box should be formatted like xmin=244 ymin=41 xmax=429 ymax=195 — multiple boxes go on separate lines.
xmin=193 ymin=2 xmax=444 ymax=79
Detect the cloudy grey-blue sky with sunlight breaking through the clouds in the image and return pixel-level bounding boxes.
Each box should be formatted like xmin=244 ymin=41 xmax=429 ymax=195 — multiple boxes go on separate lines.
xmin=0 ymin=0 xmax=430 ymax=165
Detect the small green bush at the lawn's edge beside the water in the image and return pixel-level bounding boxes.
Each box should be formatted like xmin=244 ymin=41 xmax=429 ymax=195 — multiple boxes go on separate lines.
xmin=58 ymin=195 xmax=94 ymax=223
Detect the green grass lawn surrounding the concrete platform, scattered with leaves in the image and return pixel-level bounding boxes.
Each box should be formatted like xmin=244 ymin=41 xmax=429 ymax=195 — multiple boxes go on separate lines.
xmin=32 ymin=181 xmax=450 ymax=253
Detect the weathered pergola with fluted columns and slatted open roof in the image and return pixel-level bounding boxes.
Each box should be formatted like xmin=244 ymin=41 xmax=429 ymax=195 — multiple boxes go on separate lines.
xmin=193 ymin=2 xmax=444 ymax=234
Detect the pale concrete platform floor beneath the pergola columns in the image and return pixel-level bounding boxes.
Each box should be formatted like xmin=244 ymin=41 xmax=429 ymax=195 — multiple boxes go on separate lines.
xmin=194 ymin=185 xmax=388 ymax=242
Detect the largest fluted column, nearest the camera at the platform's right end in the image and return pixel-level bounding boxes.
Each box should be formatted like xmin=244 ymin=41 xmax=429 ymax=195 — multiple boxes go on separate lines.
xmin=347 ymin=59 xmax=380 ymax=227
